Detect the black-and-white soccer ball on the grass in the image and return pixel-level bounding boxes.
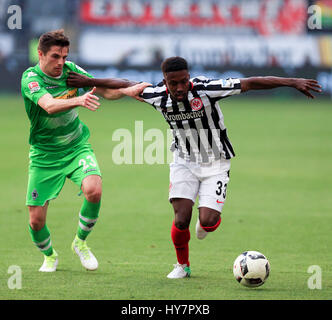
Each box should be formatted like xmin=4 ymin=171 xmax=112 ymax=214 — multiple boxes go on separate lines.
xmin=233 ymin=251 xmax=270 ymax=287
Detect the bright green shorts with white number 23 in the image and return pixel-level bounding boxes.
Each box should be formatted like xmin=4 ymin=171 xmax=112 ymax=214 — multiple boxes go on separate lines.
xmin=26 ymin=143 xmax=101 ymax=206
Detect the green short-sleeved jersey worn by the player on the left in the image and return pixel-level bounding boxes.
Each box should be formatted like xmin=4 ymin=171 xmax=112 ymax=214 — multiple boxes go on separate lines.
xmin=21 ymin=61 xmax=92 ymax=158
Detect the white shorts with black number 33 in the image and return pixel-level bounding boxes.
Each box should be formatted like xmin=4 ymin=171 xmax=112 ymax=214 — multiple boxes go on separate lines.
xmin=169 ymin=157 xmax=231 ymax=212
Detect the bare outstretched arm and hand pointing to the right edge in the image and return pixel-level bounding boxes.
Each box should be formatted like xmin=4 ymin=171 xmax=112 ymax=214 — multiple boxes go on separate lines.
xmin=240 ymin=77 xmax=322 ymax=99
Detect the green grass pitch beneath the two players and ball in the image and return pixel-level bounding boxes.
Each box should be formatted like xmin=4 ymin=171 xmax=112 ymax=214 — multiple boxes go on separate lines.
xmin=0 ymin=96 xmax=332 ymax=300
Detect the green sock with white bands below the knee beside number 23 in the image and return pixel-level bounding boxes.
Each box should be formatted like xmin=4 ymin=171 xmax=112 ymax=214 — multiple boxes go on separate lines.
xmin=77 ymin=199 xmax=100 ymax=240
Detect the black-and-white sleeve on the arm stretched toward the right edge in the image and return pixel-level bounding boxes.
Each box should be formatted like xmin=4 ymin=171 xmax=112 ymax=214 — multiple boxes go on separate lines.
xmin=192 ymin=77 xmax=241 ymax=99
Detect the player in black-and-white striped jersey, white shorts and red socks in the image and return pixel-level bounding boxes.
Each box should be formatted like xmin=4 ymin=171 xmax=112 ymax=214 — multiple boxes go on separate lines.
xmin=68 ymin=57 xmax=321 ymax=279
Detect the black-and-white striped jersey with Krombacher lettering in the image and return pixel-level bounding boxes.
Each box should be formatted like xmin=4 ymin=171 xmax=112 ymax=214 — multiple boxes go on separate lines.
xmin=141 ymin=76 xmax=241 ymax=163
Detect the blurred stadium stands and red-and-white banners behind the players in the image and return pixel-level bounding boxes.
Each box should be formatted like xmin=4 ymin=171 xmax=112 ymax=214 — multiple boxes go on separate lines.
xmin=0 ymin=0 xmax=332 ymax=96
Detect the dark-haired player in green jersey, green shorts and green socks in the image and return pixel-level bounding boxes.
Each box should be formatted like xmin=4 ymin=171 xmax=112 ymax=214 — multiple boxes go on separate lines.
xmin=21 ymin=30 xmax=148 ymax=272
